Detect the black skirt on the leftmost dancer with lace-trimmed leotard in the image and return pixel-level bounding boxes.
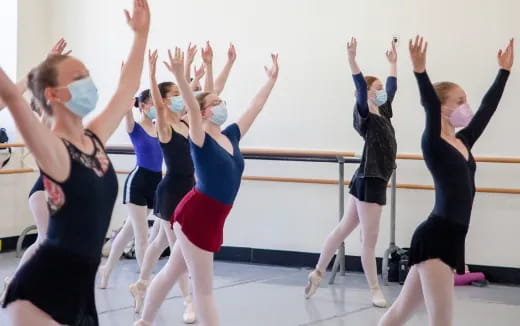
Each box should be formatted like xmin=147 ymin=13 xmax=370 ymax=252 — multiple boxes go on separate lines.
xmin=3 ymin=243 xmax=100 ymax=326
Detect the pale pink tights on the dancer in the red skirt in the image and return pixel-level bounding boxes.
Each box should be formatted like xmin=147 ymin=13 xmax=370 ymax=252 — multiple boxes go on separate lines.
xmin=138 ymin=221 xmax=220 ymax=326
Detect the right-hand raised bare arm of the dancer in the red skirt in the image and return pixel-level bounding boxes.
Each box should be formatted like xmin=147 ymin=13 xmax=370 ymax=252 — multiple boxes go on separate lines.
xmin=237 ymin=54 xmax=279 ymax=137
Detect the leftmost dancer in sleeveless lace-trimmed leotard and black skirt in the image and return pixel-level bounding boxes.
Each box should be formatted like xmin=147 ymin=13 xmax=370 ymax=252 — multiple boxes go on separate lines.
xmin=0 ymin=0 xmax=150 ymax=326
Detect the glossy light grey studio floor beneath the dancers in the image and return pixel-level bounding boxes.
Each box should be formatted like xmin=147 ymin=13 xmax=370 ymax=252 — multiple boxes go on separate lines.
xmin=0 ymin=253 xmax=520 ymax=326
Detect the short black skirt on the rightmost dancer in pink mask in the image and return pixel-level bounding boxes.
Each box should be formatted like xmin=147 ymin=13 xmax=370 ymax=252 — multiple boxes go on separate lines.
xmin=409 ymin=215 xmax=468 ymax=274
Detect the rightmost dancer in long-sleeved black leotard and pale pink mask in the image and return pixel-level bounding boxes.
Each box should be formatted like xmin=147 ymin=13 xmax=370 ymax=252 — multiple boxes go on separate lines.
xmin=379 ymin=37 xmax=514 ymax=326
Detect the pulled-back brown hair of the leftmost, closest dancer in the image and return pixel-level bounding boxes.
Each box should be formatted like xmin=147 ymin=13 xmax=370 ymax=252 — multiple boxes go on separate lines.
xmin=27 ymin=54 xmax=68 ymax=116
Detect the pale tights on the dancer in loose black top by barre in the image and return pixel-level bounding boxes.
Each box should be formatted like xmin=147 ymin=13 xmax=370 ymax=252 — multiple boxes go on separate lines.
xmin=316 ymin=196 xmax=383 ymax=290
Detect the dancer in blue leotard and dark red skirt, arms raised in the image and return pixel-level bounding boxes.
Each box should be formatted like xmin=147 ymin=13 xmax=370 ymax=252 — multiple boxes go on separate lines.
xmin=136 ymin=48 xmax=278 ymax=326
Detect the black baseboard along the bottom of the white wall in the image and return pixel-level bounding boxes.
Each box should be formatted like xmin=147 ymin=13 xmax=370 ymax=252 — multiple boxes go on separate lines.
xmin=215 ymin=247 xmax=520 ymax=285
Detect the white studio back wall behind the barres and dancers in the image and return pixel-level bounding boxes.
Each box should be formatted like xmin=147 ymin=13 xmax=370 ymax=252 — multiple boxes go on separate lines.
xmin=0 ymin=0 xmax=520 ymax=267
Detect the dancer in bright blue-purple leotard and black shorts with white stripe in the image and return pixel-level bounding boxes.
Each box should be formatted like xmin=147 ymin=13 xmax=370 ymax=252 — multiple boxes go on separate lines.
xmin=99 ymin=90 xmax=163 ymax=289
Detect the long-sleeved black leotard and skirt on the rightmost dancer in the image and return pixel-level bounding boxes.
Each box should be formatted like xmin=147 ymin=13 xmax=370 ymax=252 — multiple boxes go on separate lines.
xmin=410 ymin=69 xmax=509 ymax=273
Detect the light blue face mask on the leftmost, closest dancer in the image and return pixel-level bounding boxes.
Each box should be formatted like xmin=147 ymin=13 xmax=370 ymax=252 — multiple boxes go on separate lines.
xmin=65 ymin=77 xmax=98 ymax=118
